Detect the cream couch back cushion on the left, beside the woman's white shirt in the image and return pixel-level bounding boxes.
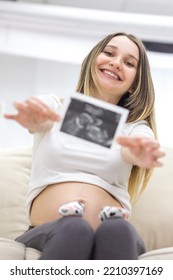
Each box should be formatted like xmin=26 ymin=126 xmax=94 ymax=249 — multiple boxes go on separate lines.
xmin=0 ymin=147 xmax=31 ymax=239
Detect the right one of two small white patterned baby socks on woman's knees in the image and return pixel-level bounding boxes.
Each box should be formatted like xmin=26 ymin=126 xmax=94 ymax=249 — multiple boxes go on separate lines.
xmin=99 ymin=206 xmax=128 ymax=222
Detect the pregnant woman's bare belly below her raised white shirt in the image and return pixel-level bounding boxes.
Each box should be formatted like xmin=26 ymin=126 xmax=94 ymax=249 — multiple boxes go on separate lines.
xmin=30 ymin=182 xmax=122 ymax=228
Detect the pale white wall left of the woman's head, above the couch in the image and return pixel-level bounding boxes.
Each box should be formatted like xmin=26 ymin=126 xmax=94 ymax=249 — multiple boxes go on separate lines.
xmin=0 ymin=54 xmax=80 ymax=147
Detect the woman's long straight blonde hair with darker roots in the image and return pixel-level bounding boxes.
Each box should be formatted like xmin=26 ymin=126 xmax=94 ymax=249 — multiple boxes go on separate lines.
xmin=76 ymin=32 xmax=157 ymax=204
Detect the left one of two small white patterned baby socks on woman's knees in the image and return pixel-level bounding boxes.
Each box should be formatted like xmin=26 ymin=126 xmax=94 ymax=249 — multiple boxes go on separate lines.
xmin=58 ymin=201 xmax=85 ymax=216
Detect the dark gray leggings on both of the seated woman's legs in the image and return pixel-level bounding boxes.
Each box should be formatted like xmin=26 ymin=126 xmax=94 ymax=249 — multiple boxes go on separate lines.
xmin=16 ymin=217 xmax=145 ymax=260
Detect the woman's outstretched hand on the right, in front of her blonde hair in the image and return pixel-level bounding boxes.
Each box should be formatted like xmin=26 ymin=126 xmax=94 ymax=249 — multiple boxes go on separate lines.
xmin=117 ymin=136 xmax=165 ymax=168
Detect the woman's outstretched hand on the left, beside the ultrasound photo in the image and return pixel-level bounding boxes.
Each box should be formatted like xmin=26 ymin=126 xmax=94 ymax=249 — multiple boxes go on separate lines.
xmin=4 ymin=96 xmax=60 ymax=132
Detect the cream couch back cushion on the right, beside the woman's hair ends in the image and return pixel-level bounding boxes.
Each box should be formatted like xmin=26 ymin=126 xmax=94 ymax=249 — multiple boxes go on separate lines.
xmin=131 ymin=148 xmax=173 ymax=251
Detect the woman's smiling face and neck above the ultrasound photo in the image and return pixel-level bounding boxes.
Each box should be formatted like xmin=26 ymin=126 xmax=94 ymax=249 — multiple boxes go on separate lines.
xmin=95 ymin=35 xmax=139 ymax=104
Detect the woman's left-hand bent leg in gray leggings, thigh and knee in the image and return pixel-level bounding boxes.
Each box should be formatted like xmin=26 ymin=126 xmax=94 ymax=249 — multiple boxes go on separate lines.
xmin=16 ymin=217 xmax=94 ymax=255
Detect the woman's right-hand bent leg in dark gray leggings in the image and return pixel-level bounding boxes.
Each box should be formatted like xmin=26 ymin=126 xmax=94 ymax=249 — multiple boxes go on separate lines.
xmin=95 ymin=218 xmax=145 ymax=260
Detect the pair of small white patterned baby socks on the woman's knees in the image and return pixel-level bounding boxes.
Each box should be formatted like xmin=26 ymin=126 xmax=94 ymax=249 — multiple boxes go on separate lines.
xmin=59 ymin=201 xmax=128 ymax=222
